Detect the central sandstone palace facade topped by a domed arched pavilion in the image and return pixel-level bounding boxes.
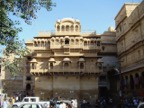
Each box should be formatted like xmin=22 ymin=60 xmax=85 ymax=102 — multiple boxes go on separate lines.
xmin=26 ymin=18 xmax=116 ymax=102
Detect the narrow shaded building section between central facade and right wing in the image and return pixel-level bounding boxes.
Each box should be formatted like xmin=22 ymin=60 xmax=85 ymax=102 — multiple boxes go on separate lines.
xmin=99 ymin=27 xmax=119 ymax=97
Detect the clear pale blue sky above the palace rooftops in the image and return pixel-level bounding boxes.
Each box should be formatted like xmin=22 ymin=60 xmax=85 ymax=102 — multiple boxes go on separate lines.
xmin=16 ymin=0 xmax=142 ymax=41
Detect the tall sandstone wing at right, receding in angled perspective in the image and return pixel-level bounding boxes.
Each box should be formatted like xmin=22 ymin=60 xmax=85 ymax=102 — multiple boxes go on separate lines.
xmin=115 ymin=2 xmax=144 ymax=96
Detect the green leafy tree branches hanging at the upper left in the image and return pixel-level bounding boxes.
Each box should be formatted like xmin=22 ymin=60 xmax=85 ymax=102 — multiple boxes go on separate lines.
xmin=0 ymin=0 xmax=55 ymax=75
